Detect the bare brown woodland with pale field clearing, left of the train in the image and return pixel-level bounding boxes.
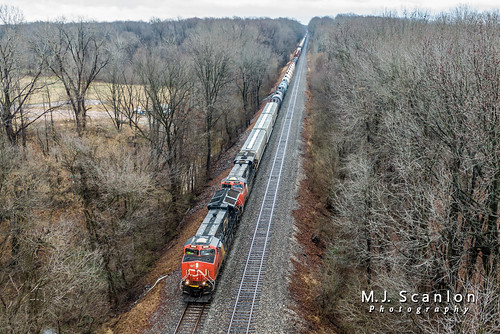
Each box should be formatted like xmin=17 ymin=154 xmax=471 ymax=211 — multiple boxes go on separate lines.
xmin=0 ymin=6 xmax=304 ymax=333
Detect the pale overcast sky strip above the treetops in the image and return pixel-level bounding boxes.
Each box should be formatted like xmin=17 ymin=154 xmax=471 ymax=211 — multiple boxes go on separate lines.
xmin=0 ymin=0 xmax=500 ymax=24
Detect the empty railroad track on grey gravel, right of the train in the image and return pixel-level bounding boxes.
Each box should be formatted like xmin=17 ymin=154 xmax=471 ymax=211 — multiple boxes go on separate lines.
xmin=227 ymin=41 xmax=304 ymax=334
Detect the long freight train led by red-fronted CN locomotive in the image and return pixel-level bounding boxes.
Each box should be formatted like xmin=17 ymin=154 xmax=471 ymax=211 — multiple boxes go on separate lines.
xmin=181 ymin=33 xmax=307 ymax=302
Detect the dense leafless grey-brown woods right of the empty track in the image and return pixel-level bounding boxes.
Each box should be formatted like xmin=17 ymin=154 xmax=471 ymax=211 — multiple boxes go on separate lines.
xmin=309 ymin=9 xmax=500 ymax=333
